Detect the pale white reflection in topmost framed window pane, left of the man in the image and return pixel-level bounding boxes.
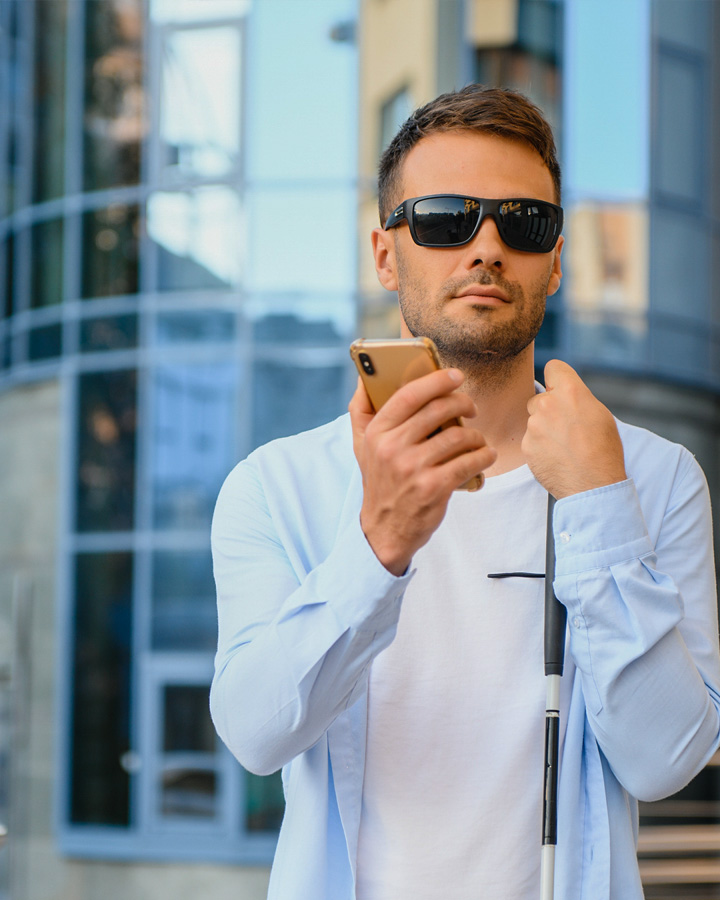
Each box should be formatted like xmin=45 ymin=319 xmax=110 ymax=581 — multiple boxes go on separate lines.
xmin=160 ymin=26 xmax=241 ymax=178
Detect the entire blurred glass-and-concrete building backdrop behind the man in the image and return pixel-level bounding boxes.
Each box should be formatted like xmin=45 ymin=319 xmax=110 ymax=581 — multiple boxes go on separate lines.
xmin=0 ymin=0 xmax=720 ymax=900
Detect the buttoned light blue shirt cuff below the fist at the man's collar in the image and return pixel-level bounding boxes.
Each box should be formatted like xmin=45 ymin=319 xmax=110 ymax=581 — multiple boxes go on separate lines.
xmin=553 ymin=478 xmax=653 ymax=577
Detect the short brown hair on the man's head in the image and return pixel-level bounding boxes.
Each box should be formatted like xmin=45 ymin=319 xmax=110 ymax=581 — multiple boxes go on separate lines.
xmin=378 ymin=84 xmax=560 ymax=225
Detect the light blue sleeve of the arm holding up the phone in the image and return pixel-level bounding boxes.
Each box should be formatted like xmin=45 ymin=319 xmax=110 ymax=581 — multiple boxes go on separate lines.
xmin=210 ymin=461 xmax=412 ymax=774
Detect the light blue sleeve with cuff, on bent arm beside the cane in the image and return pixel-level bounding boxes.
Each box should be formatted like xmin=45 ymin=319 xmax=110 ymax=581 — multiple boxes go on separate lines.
xmin=553 ymin=451 xmax=720 ymax=800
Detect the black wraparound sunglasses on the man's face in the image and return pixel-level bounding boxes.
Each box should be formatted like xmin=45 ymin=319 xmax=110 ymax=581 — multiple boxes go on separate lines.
xmin=385 ymin=194 xmax=563 ymax=253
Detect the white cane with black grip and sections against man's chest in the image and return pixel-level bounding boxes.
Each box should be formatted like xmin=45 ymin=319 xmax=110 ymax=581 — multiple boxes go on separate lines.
xmin=540 ymin=494 xmax=567 ymax=900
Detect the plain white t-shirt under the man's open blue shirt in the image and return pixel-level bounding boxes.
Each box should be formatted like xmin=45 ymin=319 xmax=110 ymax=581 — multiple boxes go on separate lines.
xmin=357 ymin=466 xmax=572 ymax=900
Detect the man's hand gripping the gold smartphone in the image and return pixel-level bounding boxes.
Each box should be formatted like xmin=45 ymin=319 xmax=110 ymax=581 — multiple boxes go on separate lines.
xmin=348 ymin=369 xmax=497 ymax=575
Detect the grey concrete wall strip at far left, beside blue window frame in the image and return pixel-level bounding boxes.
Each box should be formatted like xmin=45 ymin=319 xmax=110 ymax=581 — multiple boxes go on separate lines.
xmin=0 ymin=381 xmax=61 ymax=900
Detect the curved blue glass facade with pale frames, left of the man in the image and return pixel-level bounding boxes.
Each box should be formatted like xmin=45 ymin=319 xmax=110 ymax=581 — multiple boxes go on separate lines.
xmin=0 ymin=0 xmax=357 ymax=862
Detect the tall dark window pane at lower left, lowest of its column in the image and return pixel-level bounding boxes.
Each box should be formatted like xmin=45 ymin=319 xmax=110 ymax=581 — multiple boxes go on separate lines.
xmin=71 ymin=553 xmax=132 ymax=825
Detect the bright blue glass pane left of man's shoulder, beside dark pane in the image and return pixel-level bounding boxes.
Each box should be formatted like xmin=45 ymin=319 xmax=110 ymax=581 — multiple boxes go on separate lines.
xmin=152 ymin=363 xmax=236 ymax=528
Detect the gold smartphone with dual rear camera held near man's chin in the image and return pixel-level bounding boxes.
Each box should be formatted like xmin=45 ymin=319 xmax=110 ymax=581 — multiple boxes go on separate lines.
xmin=350 ymin=337 xmax=484 ymax=491
